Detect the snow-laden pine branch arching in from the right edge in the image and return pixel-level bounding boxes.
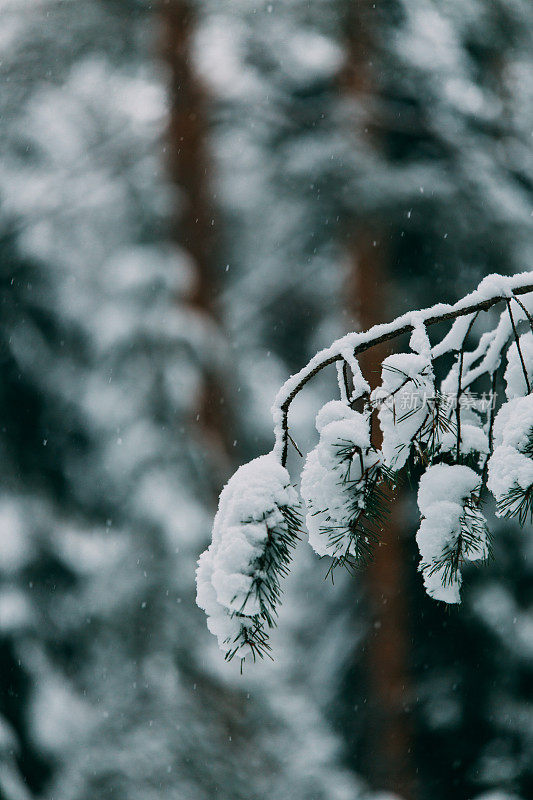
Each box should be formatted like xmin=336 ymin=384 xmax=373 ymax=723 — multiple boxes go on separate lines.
xmin=197 ymin=272 xmax=533 ymax=660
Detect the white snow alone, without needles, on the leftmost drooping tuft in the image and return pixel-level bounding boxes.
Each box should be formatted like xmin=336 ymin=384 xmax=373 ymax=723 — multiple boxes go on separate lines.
xmin=196 ymin=453 xmax=298 ymax=658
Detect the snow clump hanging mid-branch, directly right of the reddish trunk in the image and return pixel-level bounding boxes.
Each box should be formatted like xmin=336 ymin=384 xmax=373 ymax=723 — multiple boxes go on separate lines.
xmin=371 ymin=350 xmax=435 ymax=470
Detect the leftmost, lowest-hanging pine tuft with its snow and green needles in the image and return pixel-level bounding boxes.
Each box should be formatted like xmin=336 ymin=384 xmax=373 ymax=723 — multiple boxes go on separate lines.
xmin=197 ymin=453 xmax=300 ymax=660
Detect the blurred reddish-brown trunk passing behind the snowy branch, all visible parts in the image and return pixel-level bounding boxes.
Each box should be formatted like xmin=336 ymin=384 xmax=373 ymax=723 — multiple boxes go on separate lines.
xmin=343 ymin=0 xmax=415 ymax=800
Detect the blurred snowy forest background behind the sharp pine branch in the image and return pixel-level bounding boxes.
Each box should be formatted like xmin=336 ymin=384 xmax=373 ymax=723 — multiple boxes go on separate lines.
xmin=0 ymin=0 xmax=533 ymax=800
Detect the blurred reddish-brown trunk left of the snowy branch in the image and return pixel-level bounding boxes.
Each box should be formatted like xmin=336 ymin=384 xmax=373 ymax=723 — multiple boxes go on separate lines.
xmin=160 ymin=0 xmax=235 ymax=476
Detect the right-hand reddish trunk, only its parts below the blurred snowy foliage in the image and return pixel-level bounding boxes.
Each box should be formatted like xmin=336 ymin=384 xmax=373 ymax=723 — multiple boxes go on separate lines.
xmin=348 ymin=236 xmax=414 ymax=800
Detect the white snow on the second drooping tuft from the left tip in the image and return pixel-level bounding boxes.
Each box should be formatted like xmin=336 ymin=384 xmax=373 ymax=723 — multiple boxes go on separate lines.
xmin=301 ymin=401 xmax=381 ymax=557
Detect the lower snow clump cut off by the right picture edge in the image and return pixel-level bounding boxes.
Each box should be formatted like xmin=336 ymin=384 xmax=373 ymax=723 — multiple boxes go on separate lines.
xmin=487 ymin=395 xmax=533 ymax=506
